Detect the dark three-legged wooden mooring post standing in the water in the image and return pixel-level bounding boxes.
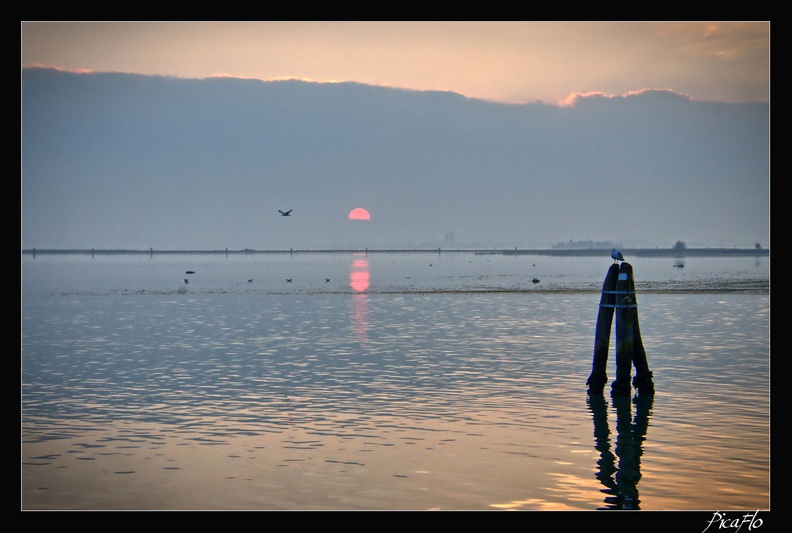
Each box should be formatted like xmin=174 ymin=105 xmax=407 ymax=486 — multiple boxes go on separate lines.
xmin=586 ymin=262 xmax=654 ymax=396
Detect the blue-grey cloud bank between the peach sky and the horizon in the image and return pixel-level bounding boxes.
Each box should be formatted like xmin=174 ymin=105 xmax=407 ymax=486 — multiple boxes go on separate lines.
xmin=21 ymin=69 xmax=770 ymax=249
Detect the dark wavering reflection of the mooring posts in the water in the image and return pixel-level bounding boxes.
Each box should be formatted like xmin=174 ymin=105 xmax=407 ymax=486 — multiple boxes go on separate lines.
xmin=588 ymin=395 xmax=654 ymax=509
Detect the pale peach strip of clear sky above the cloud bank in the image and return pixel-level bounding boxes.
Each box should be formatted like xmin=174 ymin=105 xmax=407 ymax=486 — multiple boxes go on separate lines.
xmin=21 ymin=21 xmax=770 ymax=105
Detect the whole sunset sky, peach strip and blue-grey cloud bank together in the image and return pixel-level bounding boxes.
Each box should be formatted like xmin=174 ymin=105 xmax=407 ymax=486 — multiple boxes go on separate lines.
xmin=21 ymin=21 xmax=770 ymax=250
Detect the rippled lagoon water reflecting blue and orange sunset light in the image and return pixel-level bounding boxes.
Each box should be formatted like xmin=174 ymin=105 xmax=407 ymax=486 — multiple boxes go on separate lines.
xmin=22 ymin=252 xmax=770 ymax=511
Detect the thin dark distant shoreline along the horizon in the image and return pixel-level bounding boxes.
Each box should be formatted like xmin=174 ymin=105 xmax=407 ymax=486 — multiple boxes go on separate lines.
xmin=22 ymin=248 xmax=770 ymax=258
